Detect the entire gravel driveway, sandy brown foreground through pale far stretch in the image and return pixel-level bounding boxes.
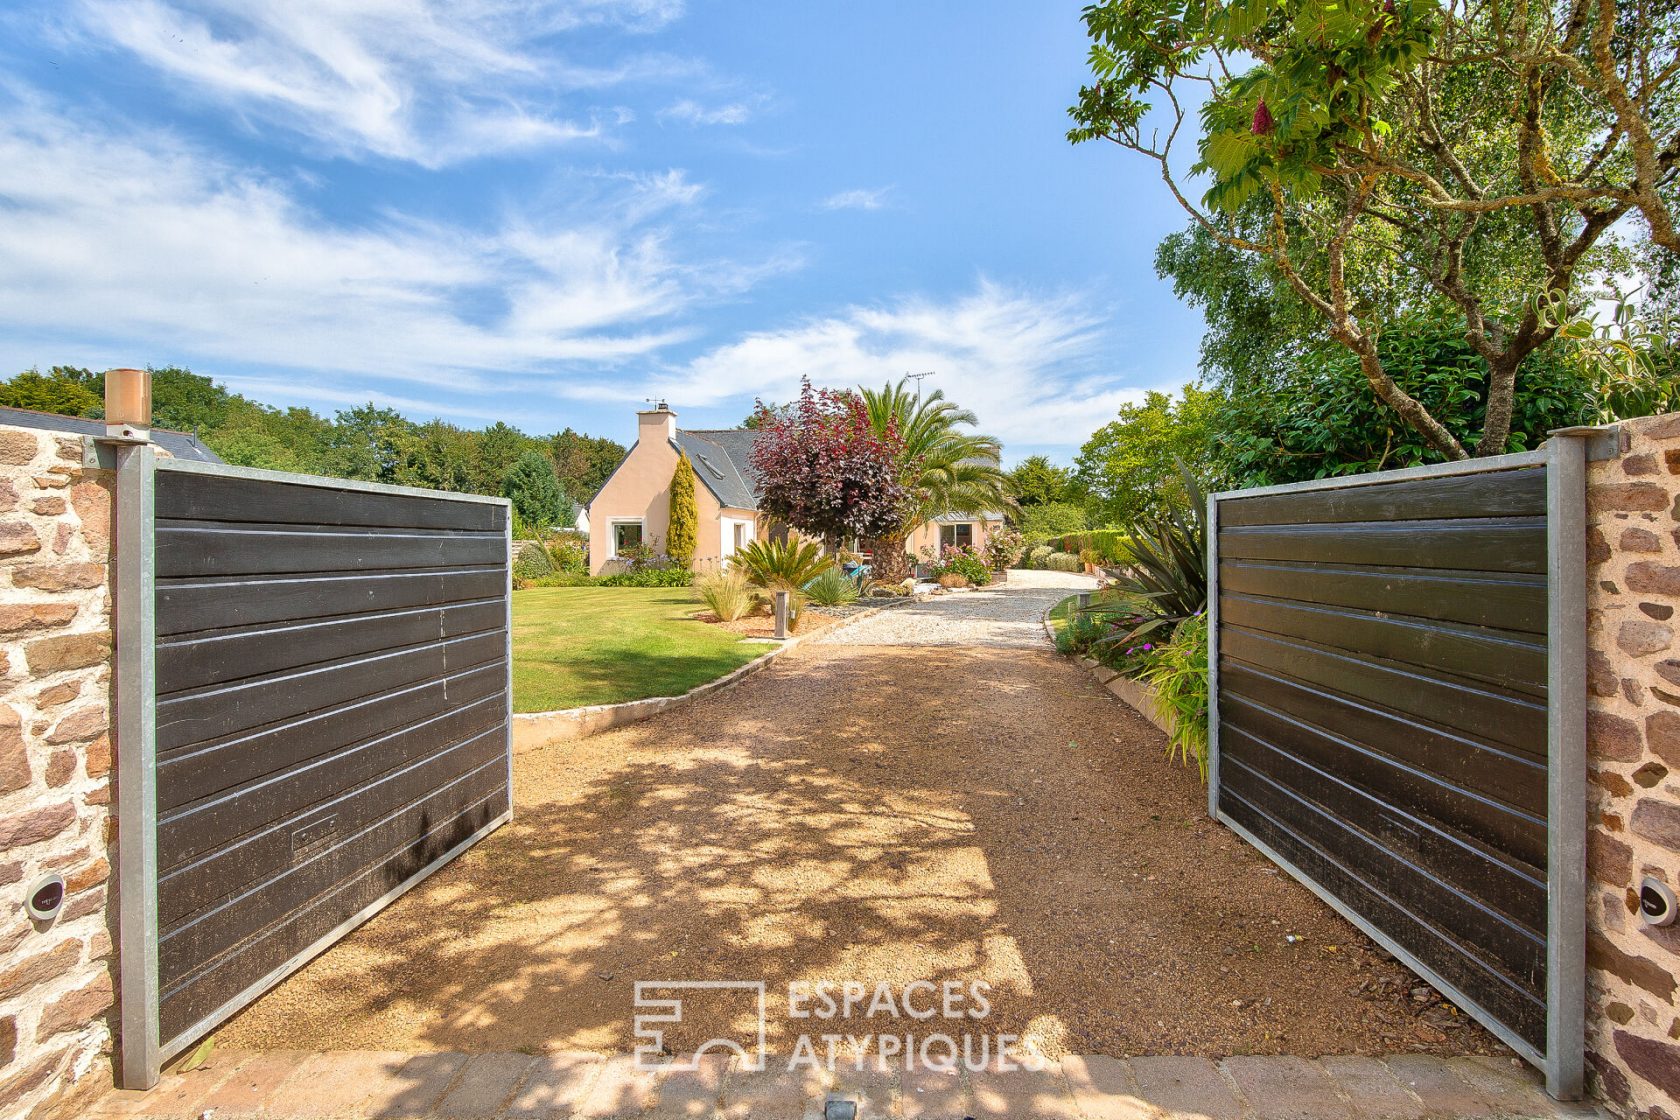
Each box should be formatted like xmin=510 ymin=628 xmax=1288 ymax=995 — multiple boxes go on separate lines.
xmin=222 ymin=573 xmax=1497 ymax=1056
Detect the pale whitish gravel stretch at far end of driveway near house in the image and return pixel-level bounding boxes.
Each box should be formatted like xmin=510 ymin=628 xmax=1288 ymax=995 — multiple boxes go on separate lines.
xmin=818 ymin=571 xmax=1097 ymax=648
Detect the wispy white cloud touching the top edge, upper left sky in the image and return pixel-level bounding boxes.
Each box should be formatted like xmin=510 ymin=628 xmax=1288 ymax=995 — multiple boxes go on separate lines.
xmin=65 ymin=0 xmax=682 ymax=168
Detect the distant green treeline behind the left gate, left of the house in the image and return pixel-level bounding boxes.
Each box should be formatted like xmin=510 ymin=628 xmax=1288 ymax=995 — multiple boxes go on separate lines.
xmin=0 ymin=366 xmax=625 ymax=504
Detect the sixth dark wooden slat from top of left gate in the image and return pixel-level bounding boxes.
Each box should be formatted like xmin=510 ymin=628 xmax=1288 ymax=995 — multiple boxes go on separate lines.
xmin=158 ymin=662 xmax=507 ymax=816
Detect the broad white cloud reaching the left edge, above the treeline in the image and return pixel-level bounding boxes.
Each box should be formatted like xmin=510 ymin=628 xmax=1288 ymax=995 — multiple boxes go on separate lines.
xmin=0 ymin=101 xmax=788 ymax=393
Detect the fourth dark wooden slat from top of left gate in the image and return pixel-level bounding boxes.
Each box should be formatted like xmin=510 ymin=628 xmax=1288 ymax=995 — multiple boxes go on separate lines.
xmin=156 ymin=598 xmax=507 ymax=695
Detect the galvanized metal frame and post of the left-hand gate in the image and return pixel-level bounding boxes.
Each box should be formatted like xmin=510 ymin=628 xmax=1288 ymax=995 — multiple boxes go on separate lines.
xmin=115 ymin=442 xmax=512 ymax=1088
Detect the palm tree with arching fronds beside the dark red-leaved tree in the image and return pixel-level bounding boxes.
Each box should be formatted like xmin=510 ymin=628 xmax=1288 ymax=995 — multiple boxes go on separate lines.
xmin=860 ymin=378 xmax=1011 ymax=581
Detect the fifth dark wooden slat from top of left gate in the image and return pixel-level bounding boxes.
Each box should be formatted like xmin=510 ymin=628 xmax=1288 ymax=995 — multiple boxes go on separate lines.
xmin=158 ymin=631 xmax=507 ymax=752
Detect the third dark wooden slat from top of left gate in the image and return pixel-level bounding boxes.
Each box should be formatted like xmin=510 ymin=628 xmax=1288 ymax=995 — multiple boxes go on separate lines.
xmin=158 ymin=566 xmax=507 ymax=638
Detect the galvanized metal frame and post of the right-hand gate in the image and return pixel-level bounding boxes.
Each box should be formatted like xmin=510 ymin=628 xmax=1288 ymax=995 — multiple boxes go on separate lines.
xmin=1206 ymin=428 xmax=1601 ymax=1100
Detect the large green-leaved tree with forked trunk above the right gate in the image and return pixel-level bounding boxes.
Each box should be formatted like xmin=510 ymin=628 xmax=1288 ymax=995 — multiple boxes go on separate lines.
xmin=1068 ymin=0 xmax=1680 ymax=458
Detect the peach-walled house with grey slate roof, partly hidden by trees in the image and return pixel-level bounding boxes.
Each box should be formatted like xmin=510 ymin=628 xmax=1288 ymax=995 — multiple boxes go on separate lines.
xmin=586 ymin=401 xmax=1003 ymax=574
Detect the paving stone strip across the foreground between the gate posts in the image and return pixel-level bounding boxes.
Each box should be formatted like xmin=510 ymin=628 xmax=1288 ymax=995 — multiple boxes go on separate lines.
xmin=94 ymin=1051 xmax=1604 ymax=1120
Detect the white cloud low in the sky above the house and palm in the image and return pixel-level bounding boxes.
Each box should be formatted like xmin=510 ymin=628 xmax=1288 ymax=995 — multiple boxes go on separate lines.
xmin=641 ymin=280 xmax=1144 ymax=445
